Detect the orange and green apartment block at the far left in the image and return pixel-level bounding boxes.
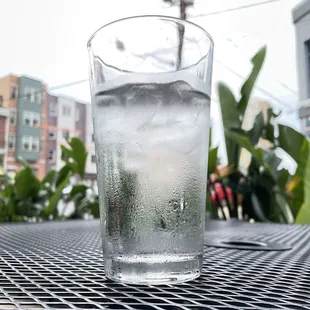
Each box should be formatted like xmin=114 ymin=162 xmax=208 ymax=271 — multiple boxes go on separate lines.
xmin=0 ymin=75 xmax=46 ymax=178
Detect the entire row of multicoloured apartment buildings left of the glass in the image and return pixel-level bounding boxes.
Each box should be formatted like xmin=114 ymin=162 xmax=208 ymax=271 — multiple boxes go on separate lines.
xmin=0 ymin=75 xmax=96 ymax=180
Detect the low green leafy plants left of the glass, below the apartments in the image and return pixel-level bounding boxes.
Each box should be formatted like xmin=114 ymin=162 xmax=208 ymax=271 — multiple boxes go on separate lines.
xmin=0 ymin=137 xmax=99 ymax=222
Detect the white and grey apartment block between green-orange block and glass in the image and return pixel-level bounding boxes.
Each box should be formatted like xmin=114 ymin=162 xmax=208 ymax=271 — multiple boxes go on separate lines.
xmin=46 ymin=94 xmax=96 ymax=179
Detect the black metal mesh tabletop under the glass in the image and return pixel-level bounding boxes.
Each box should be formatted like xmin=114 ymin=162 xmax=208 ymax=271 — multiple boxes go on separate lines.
xmin=0 ymin=221 xmax=310 ymax=310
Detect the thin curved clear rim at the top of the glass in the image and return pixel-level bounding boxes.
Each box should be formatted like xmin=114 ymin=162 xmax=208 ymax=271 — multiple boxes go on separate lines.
xmin=87 ymin=15 xmax=214 ymax=49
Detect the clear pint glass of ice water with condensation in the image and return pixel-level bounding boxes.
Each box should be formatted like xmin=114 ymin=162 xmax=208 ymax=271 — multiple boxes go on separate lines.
xmin=88 ymin=16 xmax=213 ymax=284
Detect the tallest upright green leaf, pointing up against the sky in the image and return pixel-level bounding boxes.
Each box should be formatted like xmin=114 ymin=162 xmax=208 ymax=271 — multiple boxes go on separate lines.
xmin=238 ymin=46 xmax=266 ymax=117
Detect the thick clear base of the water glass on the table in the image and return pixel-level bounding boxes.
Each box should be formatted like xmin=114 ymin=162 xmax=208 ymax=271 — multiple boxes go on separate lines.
xmin=105 ymin=254 xmax=202 ymax=285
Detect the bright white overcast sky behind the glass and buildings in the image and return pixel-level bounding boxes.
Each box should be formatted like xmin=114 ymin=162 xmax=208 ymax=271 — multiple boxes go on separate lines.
xmin=0 ymin=0 xmax=300 ymax=160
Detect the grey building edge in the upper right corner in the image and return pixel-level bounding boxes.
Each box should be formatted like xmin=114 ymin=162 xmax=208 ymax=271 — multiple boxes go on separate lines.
xmin=292 ymin=0 xmax=310 ymax=138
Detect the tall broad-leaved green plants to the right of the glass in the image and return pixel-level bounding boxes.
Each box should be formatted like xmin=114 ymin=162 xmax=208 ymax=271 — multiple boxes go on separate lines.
xmin=209 ymin=47 xmax=310 ymax=224
